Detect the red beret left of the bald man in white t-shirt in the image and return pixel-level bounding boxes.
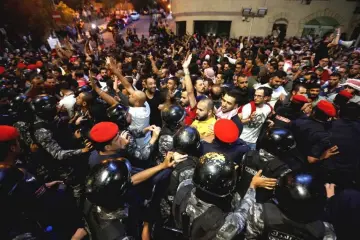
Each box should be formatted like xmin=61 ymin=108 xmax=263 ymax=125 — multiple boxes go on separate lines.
xmin=89 ymin=122 xmax=119 ymax=143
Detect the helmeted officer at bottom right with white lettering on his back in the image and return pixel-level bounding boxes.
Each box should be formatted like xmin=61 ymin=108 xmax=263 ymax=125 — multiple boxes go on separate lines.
xmin=245 ymin=172 xmax=336 ymax=240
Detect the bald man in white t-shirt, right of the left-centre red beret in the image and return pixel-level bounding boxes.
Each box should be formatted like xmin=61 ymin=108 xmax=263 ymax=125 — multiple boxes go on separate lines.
xmin=129 ymin=91 xmax=151 ymax=148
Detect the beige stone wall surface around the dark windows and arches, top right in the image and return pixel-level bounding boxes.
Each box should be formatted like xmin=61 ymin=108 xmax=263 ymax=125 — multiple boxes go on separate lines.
xmin=172 ymin=0 xmax=357 ymax=37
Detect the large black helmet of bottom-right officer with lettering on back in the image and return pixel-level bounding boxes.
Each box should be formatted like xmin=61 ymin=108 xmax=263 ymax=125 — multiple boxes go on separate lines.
xmin=274 ymin=172 xmax=326 ymax=222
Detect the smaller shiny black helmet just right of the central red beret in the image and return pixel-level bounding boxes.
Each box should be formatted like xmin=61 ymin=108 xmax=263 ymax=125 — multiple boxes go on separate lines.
xmin=261 ymin=128 xmax=296 ymax=155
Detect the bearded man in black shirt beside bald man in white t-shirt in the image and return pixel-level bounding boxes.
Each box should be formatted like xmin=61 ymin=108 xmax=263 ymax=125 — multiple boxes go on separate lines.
xmin=145 ymin=78 xmax=162 ymax=127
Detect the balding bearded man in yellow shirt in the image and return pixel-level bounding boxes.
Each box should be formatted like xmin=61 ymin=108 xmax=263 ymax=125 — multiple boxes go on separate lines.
xmin=191 ymin=98 xmax=216 ymax=141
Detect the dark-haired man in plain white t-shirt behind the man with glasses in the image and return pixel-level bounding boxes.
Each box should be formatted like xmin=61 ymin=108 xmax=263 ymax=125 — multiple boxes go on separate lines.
xmin=255 ymin=71 xmax=287 ymax=107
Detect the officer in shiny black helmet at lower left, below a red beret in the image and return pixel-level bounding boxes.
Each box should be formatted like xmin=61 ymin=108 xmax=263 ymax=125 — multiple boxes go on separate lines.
xmin=85 ymin=159 xmax=131 ymax=240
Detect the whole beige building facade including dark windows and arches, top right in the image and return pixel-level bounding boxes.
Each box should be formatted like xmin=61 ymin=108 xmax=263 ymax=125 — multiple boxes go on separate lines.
xmin=171 ymin=0 xmax=360 ymax=38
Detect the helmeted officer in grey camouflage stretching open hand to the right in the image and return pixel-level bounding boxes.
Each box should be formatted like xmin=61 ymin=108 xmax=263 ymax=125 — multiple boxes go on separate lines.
xmin=173 ymin=152 xmax=276 ymax=239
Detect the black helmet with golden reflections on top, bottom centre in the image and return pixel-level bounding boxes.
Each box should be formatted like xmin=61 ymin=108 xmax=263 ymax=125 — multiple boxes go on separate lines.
xmin=193 ymin=152 xmax=237 ymax=197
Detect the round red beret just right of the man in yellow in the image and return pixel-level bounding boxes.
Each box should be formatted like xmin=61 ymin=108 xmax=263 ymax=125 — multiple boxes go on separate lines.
xmin=214 ymin=119 xmax=239 ymax=143
